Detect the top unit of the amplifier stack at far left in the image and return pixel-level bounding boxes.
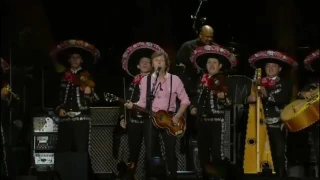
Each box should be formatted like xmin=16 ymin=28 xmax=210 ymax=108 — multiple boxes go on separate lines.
xmin=33 ymin=116 xmax=58 ymax=133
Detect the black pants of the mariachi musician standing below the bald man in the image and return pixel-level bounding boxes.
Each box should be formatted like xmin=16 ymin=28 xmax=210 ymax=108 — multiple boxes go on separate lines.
xmin=197 ymin=120 xmax=222 ymax=179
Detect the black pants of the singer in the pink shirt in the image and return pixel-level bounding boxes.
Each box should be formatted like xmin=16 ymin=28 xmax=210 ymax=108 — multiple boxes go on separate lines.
xmin=144 ymin=120 xmax=178 ymax=179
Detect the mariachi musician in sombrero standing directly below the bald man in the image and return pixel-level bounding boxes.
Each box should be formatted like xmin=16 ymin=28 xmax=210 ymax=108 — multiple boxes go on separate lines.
xmin=190 ymin=45 xmax=237 ymax=179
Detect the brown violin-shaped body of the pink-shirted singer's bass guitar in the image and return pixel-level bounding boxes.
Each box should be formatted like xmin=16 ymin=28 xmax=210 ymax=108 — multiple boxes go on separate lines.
xmin=152 ymin=111 xmax=186 ymax=136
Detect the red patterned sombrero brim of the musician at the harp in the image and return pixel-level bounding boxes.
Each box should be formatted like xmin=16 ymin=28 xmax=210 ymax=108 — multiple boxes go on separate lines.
xmin=249 ymin=50 xmax=298 ymax=68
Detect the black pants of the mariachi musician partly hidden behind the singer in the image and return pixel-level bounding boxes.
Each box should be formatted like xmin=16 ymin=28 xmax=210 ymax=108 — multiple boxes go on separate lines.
xmin=127 ymin=119 xmax=161 ymax=167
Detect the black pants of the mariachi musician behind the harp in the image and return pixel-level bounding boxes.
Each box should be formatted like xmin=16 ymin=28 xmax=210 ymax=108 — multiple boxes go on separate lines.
xmin=267 ymin=124 xmax=286 ymax=177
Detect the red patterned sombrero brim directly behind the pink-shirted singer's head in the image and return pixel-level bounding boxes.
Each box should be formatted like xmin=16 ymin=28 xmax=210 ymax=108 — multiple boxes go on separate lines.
xmin=121 ymin=42 xmax=164 ymax=76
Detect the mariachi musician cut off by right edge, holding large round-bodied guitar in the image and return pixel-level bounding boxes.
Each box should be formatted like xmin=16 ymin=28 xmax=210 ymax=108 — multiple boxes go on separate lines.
xmin=298 ymin=49 xmax=320 ymax=173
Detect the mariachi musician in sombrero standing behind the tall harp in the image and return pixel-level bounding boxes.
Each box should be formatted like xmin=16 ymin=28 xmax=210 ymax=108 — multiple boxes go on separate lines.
xmin=248 ymin=50 xmax=297 ymax=177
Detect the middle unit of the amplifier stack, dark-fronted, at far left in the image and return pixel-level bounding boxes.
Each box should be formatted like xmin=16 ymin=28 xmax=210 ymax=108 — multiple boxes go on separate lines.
xmin=33 ymin=133 xmax=58 ymax=151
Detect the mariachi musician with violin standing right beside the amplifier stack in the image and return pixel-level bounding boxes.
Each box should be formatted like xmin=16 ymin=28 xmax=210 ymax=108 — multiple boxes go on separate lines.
xmin=50 ymin=40 xmax=100 ymax=179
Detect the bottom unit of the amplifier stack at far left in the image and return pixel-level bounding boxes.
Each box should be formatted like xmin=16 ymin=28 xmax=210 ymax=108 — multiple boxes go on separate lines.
xmin=33 ymin=153 xmax=54 ymax=171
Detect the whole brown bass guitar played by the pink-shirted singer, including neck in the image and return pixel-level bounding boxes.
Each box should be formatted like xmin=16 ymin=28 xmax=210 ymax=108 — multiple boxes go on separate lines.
xmin=104 ymin=93 xmax=186 ymax=136
